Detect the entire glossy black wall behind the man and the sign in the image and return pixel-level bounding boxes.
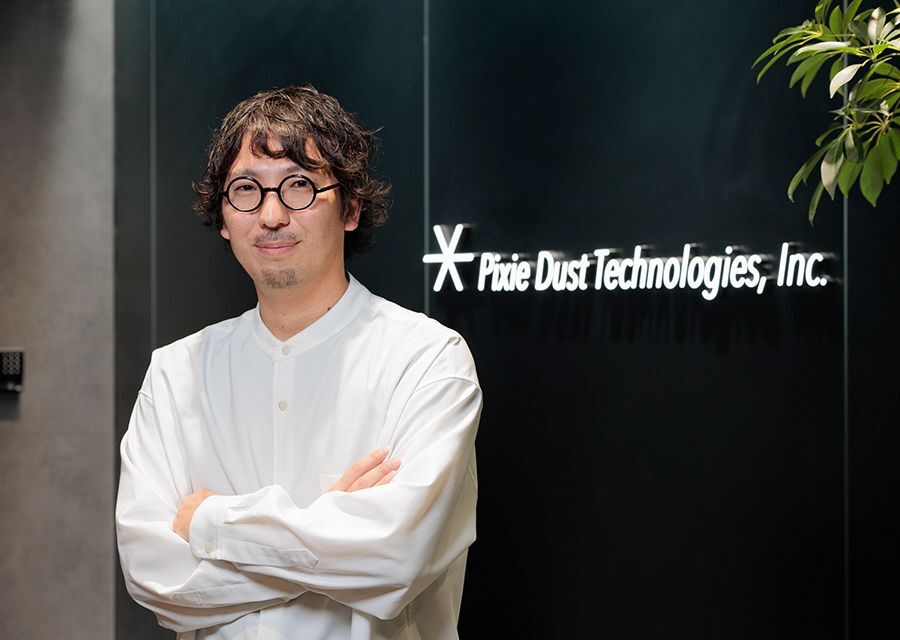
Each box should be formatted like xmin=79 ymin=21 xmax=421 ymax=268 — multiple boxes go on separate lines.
xmin=116 ymin=0 xmax=900 ymax=639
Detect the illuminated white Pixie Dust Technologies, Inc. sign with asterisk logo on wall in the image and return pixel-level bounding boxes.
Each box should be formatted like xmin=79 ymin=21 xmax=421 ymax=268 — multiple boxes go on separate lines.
xmin=422 ymin=224 xmax=833 ymax=300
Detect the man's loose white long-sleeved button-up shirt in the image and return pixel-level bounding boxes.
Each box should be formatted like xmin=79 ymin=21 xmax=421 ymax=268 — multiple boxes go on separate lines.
xmin=116 ymin=277 xmax=481 ymax=640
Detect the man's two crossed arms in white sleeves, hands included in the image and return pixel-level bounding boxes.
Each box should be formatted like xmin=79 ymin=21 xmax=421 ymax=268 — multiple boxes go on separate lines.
xmin=116 ymin=378 xmax=481 ymax=631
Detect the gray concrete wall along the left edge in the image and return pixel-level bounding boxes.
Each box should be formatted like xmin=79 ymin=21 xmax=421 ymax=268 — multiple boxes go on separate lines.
xmin=0 ymin=0 xmax=115 ymax=640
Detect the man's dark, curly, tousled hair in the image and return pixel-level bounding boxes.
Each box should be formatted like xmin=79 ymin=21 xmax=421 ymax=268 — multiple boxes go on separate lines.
xmin=193 ymin=85 xmax=391 ymax=262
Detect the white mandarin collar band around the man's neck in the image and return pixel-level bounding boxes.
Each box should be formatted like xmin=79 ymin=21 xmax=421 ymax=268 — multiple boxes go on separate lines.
xmin=253 ymin=273 xmax=371 ymax=360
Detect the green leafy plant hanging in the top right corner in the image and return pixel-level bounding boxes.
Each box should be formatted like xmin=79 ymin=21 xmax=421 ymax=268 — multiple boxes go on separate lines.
xmin=753 ymin=0 xmax=900 ymax=223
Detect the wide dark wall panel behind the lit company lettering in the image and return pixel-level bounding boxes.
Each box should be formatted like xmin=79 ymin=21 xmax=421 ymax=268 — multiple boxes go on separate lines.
xmin=430 ymin=2 xmax=844 ymax=638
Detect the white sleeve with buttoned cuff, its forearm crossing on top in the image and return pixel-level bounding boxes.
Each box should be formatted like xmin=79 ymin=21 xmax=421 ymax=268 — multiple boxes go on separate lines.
xmin=190 ymin=343 xmax=482 ymax=619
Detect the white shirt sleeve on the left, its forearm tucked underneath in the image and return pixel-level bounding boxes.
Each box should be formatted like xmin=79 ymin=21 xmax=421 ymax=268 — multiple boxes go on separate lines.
xmin=116 ymin=391 xmax=306 ymax=632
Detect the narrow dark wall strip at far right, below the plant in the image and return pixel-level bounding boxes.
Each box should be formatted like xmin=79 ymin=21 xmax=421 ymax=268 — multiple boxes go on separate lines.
xmin=847 ymin=187 xmax=900 ymax=638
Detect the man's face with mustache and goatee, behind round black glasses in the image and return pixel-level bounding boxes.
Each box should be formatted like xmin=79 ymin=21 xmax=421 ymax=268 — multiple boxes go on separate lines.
xmin=221 ymin=133 xmax=359 ymax=290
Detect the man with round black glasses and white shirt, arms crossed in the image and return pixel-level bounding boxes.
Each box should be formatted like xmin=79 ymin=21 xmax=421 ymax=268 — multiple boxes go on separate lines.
xmin=116 ymin=86 xmax=481 ymax=640
